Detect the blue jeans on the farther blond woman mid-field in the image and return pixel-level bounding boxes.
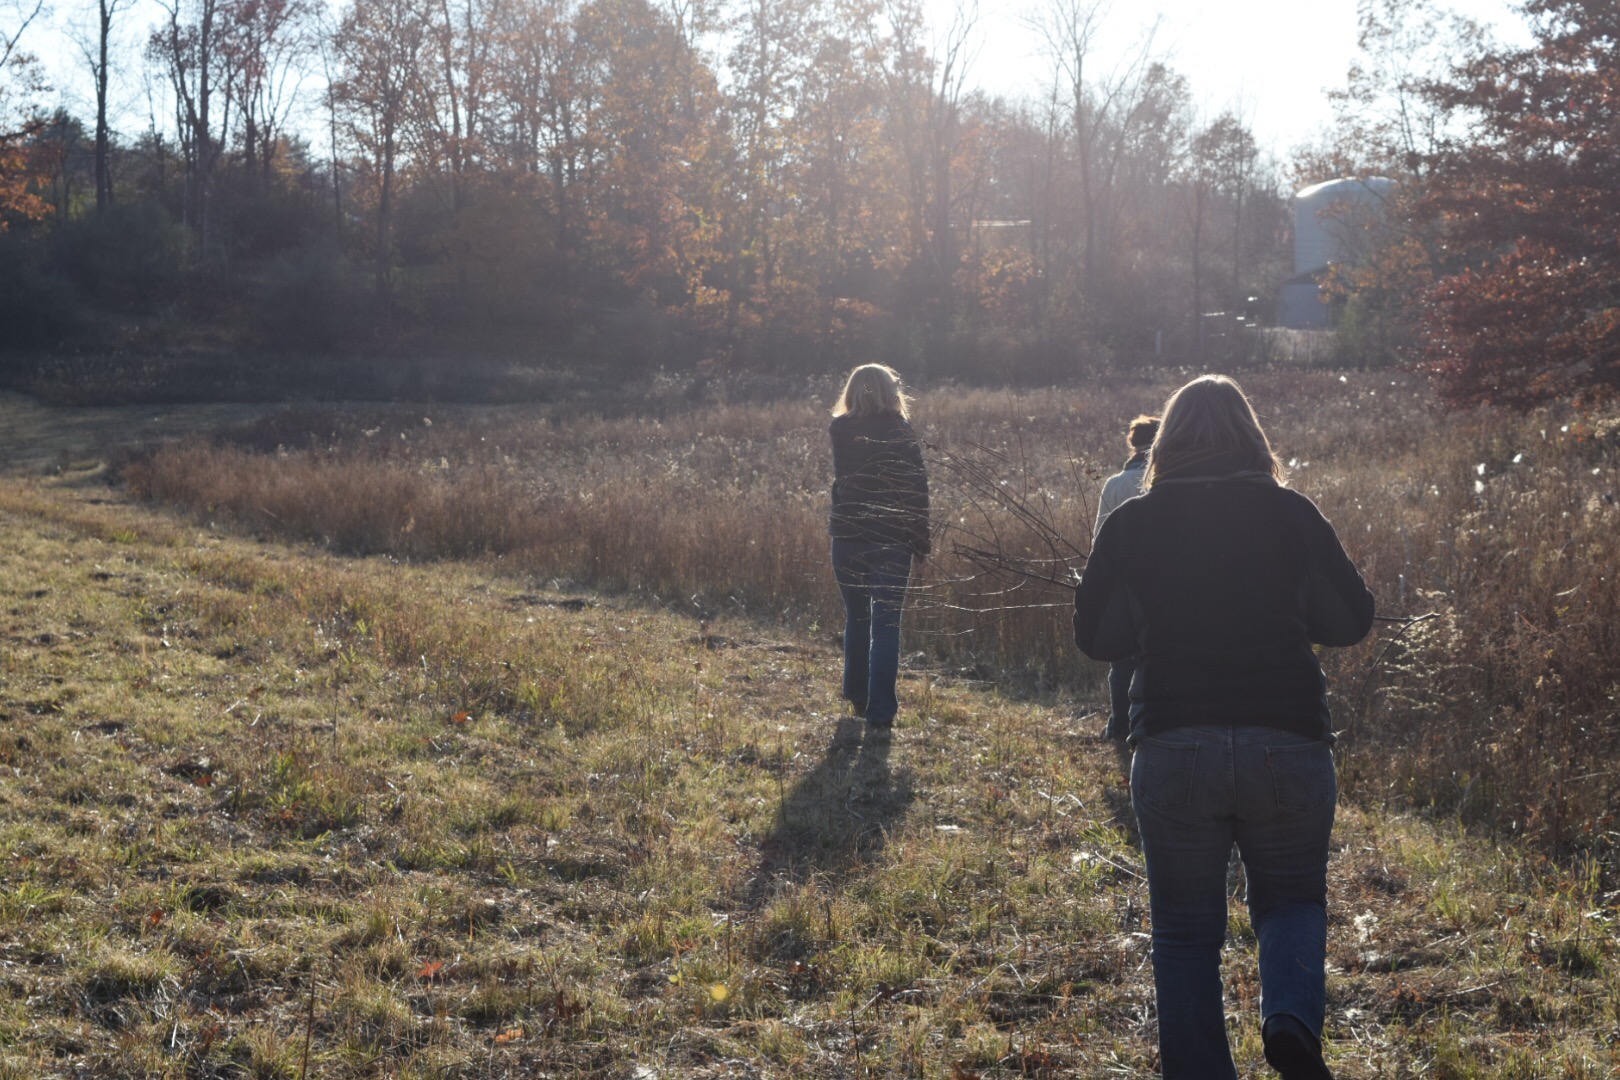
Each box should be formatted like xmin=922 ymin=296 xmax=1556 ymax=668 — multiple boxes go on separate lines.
xmin=833 ymin=539 xmax=910 ymax=725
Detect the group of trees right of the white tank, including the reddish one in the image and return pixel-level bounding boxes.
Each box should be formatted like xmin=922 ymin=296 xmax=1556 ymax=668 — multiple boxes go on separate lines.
xmin=1309 ymin=0 xmax=1620 ymax=410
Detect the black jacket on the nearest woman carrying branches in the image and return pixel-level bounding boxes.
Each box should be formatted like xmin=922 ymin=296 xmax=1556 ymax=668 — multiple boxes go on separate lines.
xmin=1074 ymin=474 xmax=1372 ymax=740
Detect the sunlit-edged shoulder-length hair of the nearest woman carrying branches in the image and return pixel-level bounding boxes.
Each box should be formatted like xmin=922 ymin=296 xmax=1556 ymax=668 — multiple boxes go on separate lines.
xmin=1142 ymin=376 xmax=1286 ymax=489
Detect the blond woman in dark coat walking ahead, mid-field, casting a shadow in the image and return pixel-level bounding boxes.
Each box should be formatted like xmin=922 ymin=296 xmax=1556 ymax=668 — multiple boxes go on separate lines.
xmin=828 ymin=364 xmax=930 ymax=733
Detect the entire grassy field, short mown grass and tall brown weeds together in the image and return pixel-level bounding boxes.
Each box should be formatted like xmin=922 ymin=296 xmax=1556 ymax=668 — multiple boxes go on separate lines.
xmin=0 ymin=372 xmax=1620 ymax=1080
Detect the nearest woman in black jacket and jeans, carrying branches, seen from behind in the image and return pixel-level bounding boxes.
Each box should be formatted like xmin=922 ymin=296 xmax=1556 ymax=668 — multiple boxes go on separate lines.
xmin=1074 ymin=376 xmax=1372 ymax=1080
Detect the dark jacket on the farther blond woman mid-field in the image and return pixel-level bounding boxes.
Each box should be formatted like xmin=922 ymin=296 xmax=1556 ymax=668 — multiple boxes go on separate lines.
xmin=828 ymin=413 xmax=930 ymax=555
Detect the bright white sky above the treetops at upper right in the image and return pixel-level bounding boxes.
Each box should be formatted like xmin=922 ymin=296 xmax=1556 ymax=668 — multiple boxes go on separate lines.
xmin=925 ymin=0 xmax=1523 ymax=155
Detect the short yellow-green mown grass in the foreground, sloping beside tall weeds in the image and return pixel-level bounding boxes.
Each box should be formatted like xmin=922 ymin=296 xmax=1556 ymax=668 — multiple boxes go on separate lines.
xmin=0 ymin=476 xmax=1620 ymax=1078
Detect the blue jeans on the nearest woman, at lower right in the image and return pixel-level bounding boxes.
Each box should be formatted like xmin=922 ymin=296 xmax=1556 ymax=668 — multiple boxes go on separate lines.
xmin=1131 ymin=727 xmax=1338 ymax=1080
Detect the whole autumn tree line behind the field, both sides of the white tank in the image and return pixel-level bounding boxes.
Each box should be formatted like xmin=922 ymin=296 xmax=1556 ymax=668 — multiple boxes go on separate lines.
xmin=0 ymin=0 xmax=1620 ymax=406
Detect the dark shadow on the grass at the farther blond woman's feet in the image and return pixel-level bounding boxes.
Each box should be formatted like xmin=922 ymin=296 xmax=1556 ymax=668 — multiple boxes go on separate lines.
xmin=744 ymin=716 xmax=915 ymax=908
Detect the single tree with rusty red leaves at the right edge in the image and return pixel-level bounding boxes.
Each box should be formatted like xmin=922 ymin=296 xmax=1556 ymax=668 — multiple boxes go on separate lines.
xmin=1416 ymin=0 xmax=1620 ymax=408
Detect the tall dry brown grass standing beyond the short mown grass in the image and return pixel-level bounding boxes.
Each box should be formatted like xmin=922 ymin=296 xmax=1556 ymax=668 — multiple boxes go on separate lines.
xmin=126 ymin=369 xmax=1620 ymax=855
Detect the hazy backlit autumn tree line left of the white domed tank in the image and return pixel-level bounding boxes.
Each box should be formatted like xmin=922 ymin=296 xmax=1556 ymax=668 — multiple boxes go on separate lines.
xmin=0 ymin=0 xmax=1288 ymax=377
